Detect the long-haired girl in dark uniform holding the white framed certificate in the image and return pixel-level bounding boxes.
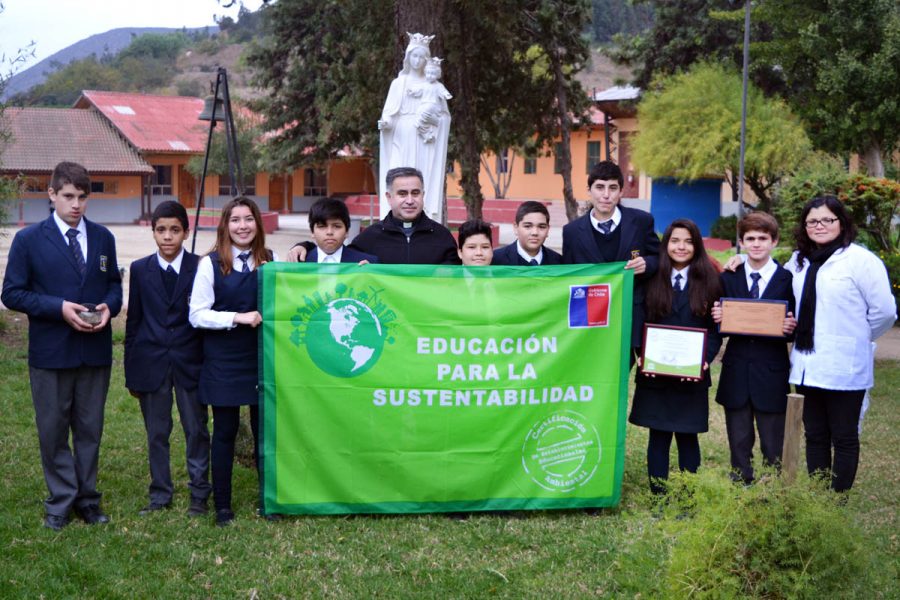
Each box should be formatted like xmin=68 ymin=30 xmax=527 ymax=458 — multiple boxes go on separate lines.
xmin=629 ymin=219 xmax=722 ymax=494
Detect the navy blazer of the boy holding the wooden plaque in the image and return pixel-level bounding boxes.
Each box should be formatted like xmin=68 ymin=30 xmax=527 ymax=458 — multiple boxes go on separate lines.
xmin=716 ymin=265 xmax=795 ymax=413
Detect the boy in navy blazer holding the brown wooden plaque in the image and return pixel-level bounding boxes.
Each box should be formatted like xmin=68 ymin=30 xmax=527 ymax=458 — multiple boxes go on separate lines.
xmin=711 ymin=212 xmax=797 ymax=484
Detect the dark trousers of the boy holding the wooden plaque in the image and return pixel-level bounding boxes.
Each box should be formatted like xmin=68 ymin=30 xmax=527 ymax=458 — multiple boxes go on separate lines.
xmin=725 ymin=402 xmax=784 ymax=483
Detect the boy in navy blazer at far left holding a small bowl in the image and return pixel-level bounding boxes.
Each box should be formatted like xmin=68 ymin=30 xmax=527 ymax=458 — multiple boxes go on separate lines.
xmin=2 ymin=162 xmax=122 ymax=531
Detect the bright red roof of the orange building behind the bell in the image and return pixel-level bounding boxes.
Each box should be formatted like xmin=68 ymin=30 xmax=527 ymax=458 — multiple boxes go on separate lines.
xmin=75 ymin=90 xmax=209 ymax=154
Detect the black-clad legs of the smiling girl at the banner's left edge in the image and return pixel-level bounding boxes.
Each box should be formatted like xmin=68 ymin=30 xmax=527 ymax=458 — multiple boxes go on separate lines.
xmin=210 ymin=406 xmax=259 ymax=510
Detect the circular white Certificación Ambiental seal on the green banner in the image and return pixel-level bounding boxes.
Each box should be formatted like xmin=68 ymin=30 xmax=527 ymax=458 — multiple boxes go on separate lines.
xmin=522 ymin=410 xmax=600 ymax=492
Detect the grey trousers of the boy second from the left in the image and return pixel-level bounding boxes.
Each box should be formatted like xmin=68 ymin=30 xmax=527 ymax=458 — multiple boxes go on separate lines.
xmin=140 ymin=369 xmax=212 ymax=504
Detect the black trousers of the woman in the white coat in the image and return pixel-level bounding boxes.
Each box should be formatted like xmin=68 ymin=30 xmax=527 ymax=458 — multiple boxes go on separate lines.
xmin=797 ymin=385 xmax=866 ymax=492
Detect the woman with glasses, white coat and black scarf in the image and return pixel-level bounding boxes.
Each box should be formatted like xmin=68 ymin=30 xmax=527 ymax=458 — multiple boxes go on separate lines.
xmin=785 ymin=196 xmax=897 ymax=492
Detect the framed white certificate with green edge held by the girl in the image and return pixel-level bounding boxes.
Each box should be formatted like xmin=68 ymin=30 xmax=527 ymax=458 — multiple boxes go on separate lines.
xmin=641 ymin=323 xmax=706 ymax=380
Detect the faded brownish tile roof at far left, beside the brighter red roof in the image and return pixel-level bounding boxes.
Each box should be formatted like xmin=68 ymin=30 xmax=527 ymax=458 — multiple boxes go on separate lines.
xmin=0 ymin=107 xmax=153 ymax=174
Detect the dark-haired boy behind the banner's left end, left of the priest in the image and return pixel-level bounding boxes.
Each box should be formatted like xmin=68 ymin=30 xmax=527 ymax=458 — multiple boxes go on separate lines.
xmin=306 ymin=197 xmax=378 ymax=264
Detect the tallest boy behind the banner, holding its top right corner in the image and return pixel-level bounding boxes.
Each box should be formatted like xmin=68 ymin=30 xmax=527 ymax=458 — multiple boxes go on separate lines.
xmin=563 ymin=160 xmax=659 ymax=352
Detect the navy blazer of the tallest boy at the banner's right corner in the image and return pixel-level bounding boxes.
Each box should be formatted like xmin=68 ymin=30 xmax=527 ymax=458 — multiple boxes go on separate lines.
xmin=562 ymin=205 xmax=659 ymax=347
